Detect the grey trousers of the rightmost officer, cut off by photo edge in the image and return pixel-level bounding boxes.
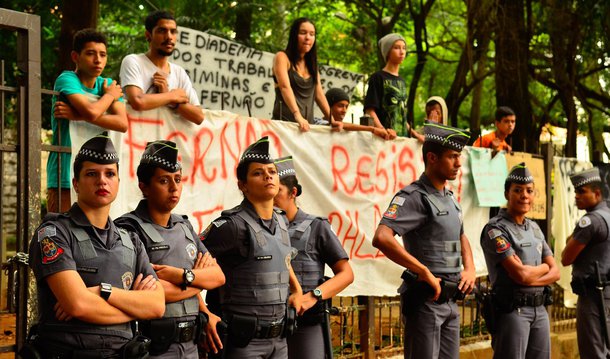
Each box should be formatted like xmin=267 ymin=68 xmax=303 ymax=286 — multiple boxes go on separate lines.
xmin=576 ymin=294 xmax=610 ymax=359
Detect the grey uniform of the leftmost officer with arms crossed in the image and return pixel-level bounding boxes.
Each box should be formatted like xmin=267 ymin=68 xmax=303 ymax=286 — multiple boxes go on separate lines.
xmin=30 ymin=203 xmax=156 ymax=357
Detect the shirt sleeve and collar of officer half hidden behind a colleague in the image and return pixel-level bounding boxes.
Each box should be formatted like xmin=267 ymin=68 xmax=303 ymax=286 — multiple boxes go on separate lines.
xmin=289 ymin=209 xmax=349 ymax=267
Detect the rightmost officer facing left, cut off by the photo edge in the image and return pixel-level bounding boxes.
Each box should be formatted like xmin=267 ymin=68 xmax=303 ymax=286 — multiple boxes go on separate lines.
xmin=561 ymin=167 xmax=610 ymax=359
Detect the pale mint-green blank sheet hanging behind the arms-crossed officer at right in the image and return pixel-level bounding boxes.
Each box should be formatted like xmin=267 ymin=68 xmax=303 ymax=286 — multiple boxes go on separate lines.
xmin=469 ymin=147 xmax=508 ymax=207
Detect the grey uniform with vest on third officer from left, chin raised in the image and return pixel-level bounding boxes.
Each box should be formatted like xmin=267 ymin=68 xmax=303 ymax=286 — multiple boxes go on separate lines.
xmin=201 ymin=199 xmax=293 ymax=358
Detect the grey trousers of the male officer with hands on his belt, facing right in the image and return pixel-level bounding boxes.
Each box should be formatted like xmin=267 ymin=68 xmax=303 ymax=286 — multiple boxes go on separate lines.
xmin=401 ymin=295 xmax=460 ymax=359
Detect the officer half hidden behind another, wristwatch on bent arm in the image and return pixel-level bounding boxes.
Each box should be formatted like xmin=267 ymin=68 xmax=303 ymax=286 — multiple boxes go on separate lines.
xmin=274 ymin=156 xmax=354 ymax=359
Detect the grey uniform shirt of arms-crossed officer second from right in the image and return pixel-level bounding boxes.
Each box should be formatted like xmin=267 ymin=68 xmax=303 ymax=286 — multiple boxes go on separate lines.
xmin=481 ymin=208 xmax=553 ymax=292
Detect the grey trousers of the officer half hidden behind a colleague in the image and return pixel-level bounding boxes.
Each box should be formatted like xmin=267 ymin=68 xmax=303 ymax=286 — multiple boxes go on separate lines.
xmin=287 ymin=324 xmax=325 ymax=359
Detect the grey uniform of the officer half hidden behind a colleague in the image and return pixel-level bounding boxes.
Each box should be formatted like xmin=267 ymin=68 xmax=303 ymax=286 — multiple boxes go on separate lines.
xmin=288 ymin=209 xmax=349 ymax=359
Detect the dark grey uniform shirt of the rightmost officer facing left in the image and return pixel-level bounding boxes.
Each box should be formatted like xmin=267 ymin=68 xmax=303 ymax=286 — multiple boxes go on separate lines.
xmin=572 ymin=201 xmax=610 ymax=278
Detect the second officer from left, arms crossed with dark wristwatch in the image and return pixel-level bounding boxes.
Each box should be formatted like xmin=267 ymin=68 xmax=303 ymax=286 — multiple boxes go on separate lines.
xmin=115 ymin=140 xmax=225 ymax=359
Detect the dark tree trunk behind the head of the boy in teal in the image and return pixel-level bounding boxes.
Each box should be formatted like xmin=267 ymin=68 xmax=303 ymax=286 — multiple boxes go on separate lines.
xmin=57 ymin=0 xmax=99 ymax=75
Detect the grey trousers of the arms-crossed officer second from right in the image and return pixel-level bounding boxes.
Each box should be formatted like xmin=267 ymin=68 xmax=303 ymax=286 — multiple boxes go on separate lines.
xmin=491 ymin=305 xmax=551 ymax=359
